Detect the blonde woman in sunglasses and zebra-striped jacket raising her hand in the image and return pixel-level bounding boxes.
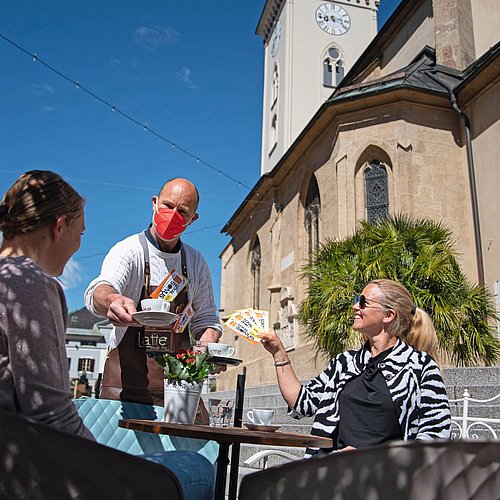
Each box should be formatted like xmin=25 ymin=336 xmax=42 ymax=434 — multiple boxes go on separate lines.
xmin=262 ymin=280 xmax=451 ymax=456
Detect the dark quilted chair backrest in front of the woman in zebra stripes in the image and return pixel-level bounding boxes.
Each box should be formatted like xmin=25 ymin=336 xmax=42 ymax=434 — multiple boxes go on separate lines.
xmin=239 ymin=441 xmax=500 ymax=500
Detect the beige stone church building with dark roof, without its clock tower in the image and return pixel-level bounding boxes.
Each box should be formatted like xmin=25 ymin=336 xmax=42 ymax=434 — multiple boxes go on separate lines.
xmin=217 ymin=0 xmax=500 ymax=390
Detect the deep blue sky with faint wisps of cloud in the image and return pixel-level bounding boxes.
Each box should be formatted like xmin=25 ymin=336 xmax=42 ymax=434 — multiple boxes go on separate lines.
xmin=0 ymin=0 xmax=399 ymax=310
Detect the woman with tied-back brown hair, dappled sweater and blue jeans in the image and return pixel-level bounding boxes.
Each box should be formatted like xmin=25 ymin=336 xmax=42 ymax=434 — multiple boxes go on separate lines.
xmin=0 ymin=170 xmax=214 ymax=499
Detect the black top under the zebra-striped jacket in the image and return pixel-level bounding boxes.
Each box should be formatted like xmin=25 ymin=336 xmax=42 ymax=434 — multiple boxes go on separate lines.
xmin=337 ymin=348 xmax=403 ymax=450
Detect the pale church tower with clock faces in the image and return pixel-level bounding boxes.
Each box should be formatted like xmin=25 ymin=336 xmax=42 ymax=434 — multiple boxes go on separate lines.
xmin=256 ymin=0 xmax=379 ymax=175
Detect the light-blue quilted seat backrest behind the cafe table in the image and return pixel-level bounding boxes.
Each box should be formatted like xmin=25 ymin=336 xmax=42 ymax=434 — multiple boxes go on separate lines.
xmin=73 ymin=398 xmax=219 ymax=463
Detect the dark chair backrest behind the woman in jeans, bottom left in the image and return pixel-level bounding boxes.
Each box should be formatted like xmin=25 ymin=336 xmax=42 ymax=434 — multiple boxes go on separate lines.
xmin=0 ymin=410 xmax=183 ymax=500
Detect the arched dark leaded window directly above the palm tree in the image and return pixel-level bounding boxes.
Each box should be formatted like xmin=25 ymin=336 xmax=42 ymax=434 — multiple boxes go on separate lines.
xmin=364 ymin=160 xmax=389 ymax=224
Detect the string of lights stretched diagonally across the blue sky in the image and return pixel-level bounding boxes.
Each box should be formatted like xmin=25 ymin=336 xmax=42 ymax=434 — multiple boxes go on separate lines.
xmin=0 ymin=33 xmax=258 ymax=191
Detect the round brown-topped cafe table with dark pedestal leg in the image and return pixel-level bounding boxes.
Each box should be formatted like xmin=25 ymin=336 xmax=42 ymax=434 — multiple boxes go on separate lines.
xmin=118 ymin=419 xmax=333 ymax=500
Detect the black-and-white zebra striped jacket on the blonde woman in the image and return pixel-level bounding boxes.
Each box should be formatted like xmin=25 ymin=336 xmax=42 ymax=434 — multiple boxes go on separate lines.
xmin=289 ymin=339 xmax=451 ymax=457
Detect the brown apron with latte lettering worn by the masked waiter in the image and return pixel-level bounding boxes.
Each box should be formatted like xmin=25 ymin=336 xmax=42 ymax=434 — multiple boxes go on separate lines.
xmin=100 ymin=234 xmax=208 ymax=424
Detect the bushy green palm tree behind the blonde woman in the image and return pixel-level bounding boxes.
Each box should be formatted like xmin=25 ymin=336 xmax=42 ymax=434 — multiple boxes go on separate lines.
xmin=299 ymin=215 xmax=500 ymax=366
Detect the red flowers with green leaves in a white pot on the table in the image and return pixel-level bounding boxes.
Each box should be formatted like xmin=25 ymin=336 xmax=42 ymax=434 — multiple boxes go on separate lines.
xmin=156 ymin=349 xmax=215 ymax=424
